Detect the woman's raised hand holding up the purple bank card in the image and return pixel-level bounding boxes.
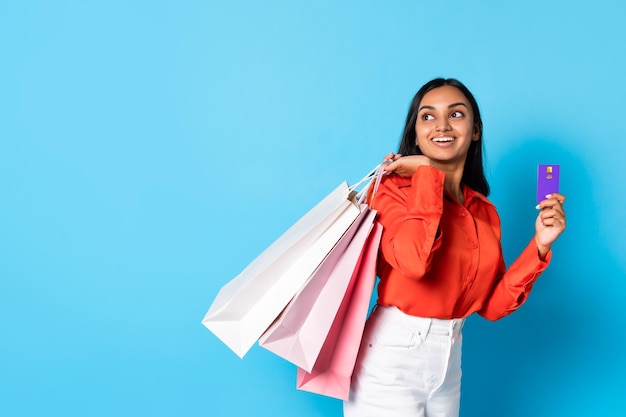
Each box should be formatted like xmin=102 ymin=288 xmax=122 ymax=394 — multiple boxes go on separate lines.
xmin=535 ymin=193 xmax=565 ymax=259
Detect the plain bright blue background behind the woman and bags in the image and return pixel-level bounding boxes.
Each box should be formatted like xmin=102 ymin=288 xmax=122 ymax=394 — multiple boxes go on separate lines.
xmin=0 ymin=0 xmax=626 ymax=417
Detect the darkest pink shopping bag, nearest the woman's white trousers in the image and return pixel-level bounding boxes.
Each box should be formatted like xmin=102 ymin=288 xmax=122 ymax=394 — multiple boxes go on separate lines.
xmin=296 ymin=223 xmax=382 ymax=401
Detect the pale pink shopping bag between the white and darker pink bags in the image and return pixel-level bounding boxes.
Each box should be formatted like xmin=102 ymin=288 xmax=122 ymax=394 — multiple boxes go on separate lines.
xmin=259 ymin=207 xmax=376 ymax=372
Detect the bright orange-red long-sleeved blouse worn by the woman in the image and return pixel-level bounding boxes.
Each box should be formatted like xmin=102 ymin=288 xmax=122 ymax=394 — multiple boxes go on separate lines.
xmin=371 ymin=166 xmax=552 ymax=320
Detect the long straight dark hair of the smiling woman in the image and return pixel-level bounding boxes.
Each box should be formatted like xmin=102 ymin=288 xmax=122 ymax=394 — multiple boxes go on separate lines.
xmin=398 ymin=78 xmax=489 ymax=196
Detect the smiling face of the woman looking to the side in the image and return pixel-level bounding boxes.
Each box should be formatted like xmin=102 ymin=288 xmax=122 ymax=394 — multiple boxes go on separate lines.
xmin=415 ymin=85 xmax=480 ymax=166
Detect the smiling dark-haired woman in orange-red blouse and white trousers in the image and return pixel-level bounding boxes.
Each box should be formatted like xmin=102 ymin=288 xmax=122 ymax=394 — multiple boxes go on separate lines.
xmin=344 ymin=78 xmax=565 ymax=417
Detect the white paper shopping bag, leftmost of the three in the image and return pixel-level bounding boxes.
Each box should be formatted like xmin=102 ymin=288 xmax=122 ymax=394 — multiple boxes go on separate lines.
xmin=202 ymin=167 xmax=379 ymax=357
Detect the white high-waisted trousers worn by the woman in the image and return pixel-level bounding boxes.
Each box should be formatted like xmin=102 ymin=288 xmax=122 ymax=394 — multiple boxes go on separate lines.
xmin=343 ymin=306 xmax=464 ymax=417
